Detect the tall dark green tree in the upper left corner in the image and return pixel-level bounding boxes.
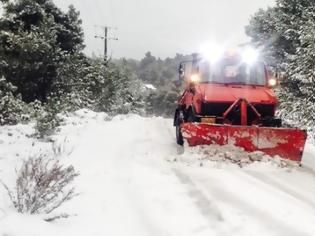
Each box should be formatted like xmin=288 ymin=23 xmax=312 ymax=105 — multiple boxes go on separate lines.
xmin=0 ymin=0 xmax=84 ymax=102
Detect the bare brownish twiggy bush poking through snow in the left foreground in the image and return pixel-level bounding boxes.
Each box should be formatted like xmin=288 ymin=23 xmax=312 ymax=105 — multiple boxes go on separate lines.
xmin=3 ymin=156 xmax=78 ymax=218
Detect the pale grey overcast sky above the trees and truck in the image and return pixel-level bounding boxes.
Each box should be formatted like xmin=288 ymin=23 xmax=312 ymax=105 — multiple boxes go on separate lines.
xmin=4 ymin=0 xmax=274 ymax=58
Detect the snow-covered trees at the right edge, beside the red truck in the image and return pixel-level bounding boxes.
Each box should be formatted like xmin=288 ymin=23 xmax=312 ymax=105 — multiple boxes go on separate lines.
xmin=246 ymin=0 xmax=315 ymax=134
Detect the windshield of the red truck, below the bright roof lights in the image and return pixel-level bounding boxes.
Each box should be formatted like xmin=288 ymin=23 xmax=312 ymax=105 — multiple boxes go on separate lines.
xmin=198 ymin=60 xmax=266 ymax=86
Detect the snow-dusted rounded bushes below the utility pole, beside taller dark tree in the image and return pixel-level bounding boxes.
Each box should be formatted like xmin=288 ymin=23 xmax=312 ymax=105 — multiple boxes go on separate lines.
xmin=52 ymin=54 xmax=144 ymax=114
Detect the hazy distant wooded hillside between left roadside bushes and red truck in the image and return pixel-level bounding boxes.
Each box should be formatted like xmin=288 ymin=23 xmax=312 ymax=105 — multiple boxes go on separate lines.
xmin=115 ymin=52 xmax=190 ymax=117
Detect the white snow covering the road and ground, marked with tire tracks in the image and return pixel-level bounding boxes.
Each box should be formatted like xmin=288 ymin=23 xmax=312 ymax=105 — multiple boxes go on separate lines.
xmin=0 ymin=111 xmax=315 ymax=236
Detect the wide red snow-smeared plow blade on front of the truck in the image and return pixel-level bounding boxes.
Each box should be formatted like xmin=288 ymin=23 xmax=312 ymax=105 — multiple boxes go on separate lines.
xmin=181 ymin=123 xmax=307 ymax=162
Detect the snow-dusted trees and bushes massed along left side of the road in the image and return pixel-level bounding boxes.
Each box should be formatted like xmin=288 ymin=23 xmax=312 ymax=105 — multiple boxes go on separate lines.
xmin=0 ymin=0 xmax=143 ymax=136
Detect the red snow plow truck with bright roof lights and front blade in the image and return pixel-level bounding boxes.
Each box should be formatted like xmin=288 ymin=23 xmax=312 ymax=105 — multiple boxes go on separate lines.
xmin=174 ymin=47 xmax=307 ymax=163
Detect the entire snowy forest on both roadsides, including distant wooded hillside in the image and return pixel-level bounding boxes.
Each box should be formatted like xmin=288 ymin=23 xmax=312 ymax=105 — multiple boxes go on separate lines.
xmin=0 ymin=0 xmax=315 ymax=136
